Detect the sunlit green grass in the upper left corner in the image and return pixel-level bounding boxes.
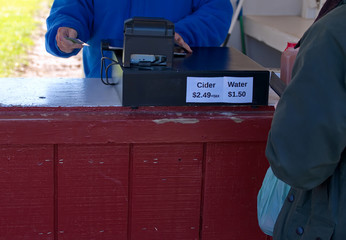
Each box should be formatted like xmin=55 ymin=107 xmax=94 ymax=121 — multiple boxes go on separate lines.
xmin=0 ymin=0 xmax=47 ymax=77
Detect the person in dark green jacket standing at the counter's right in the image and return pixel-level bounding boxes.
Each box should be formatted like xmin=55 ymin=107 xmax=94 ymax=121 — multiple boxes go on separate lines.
xmin=266 ymin=0 xmax=346 ymax=240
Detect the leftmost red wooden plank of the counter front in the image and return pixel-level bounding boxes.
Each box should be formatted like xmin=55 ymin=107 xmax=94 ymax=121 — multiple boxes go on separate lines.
xmin=0 ymin=145 xmax=54 ymax=240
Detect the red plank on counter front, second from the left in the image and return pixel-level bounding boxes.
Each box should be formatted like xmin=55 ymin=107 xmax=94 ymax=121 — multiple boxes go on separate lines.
xmin=57 ymin=145 xmax=129 ymax=240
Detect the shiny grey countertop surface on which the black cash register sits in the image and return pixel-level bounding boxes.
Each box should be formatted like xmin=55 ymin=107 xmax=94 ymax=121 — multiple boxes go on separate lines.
xmin=0 ymin=78 xmax=278 ymax=107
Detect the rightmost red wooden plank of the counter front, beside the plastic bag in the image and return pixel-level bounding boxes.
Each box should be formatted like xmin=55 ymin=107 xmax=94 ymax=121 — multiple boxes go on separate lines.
xmin=202 ymin=142 xmax=268 ymax=240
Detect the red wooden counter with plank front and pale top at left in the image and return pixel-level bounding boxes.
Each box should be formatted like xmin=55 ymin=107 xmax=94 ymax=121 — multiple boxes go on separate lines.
xmin=0 ymin=79 xmax=274 ymax=240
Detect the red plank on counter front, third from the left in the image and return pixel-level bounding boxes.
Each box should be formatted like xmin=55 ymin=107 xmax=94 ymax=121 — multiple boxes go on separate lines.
xmin=130 ymin=144 xmax=203 ymax=240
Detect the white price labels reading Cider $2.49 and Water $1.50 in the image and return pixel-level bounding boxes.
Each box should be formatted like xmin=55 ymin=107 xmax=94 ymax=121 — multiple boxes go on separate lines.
xmin=186 ymin=76 xmax=253 ymax=103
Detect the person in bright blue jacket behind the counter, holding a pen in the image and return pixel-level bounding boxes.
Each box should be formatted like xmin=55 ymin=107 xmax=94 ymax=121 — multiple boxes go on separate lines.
xmin=45 ymin=0 xmax=233 ymax=77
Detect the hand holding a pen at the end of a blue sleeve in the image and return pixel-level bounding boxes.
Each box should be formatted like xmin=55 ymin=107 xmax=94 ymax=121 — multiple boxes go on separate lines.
xmin=55 ymin=27 xmax=83 ymax=53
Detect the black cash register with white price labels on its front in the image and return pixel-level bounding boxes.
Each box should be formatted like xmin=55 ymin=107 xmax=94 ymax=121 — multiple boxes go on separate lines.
xmin=101 ymin=18 xmax=270 ymax=107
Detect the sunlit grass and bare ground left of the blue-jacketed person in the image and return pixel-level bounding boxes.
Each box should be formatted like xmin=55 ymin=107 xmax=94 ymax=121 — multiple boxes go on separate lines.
xmin=0 ymin=0 xmax=83 ymax=78
